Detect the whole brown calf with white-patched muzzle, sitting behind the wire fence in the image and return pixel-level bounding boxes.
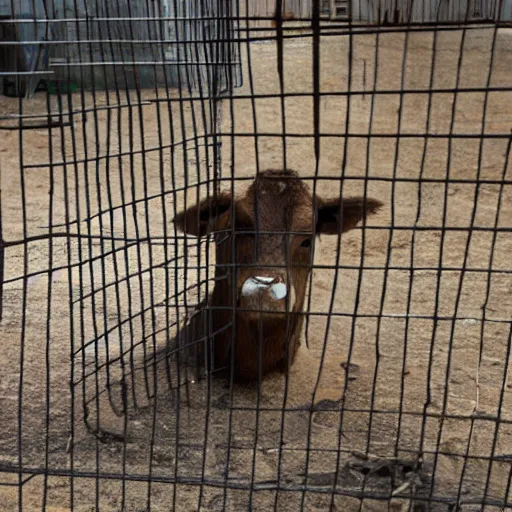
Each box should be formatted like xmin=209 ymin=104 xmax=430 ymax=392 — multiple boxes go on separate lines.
xmin=174 ymin=170 xmax=382 ymax=379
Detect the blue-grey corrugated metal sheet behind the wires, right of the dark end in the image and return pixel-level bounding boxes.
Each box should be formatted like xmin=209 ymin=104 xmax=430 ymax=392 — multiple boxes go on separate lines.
xmin=42 ymin=0 xmax=240 ymax=90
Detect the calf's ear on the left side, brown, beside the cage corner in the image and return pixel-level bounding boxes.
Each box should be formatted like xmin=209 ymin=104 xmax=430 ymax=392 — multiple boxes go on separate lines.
xmin=173 ymin=192 xmax=232 ymax=236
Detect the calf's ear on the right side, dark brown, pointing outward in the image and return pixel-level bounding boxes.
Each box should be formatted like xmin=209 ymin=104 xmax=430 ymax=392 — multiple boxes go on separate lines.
xmin=316 ymin=197 xmax=383 ymax=235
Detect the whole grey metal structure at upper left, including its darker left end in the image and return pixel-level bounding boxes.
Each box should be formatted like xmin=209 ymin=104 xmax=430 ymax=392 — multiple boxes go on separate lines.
xmin=0 ymin=0 xmax=241 ymax=96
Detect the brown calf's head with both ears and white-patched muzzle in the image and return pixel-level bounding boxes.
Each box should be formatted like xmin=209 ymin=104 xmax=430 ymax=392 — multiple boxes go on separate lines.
xmin=175 ymin=170 xmax=382 ymax=320
